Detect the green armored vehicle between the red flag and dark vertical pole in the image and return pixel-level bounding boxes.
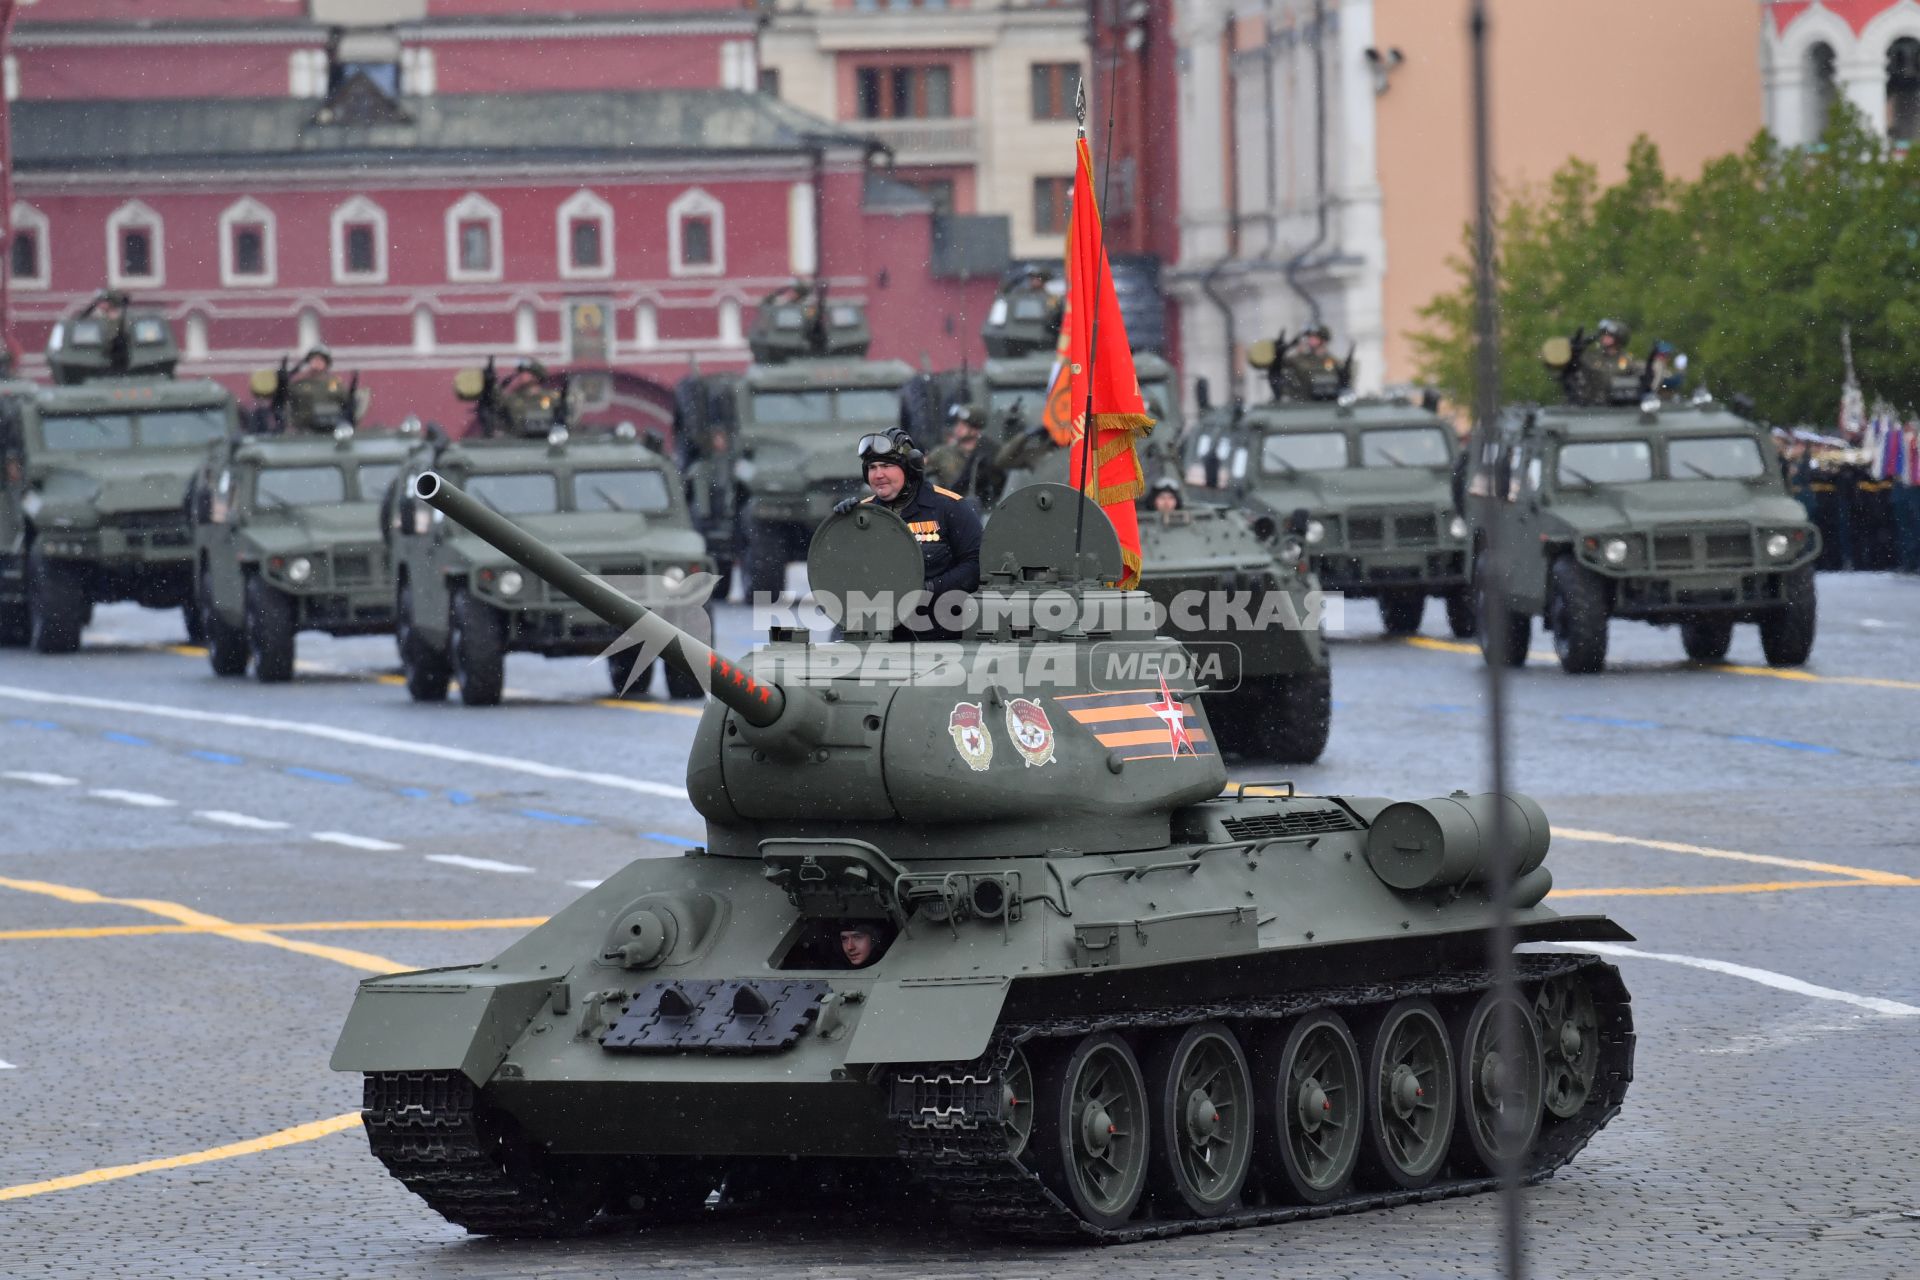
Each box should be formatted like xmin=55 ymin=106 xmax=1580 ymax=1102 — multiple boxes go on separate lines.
xmin=1187 ymin=342 xmax=1475 ymax=637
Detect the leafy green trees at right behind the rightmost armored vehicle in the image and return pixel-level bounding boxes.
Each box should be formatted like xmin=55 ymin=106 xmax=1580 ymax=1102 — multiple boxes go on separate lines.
xmin=1409 ymin=107 xmax=1920 ymax=422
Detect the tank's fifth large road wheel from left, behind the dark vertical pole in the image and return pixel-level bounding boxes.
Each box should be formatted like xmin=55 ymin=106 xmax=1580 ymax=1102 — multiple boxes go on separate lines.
xmin=1455 ymin=992 xmax=1542 ymax=1173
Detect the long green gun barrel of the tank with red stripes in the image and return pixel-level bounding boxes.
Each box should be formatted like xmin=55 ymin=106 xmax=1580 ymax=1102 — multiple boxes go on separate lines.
xmin=413 ymin=472 xmax=787 ymax=727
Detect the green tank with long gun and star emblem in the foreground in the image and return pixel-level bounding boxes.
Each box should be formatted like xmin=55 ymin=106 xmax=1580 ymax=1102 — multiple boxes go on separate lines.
xmin=332 ymin=474 xmax=1634 ymax=1240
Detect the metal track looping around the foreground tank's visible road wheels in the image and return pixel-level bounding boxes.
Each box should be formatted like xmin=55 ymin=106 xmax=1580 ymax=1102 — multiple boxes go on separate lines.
xmin=889 ymin=954 xmax=1634 ymax=1244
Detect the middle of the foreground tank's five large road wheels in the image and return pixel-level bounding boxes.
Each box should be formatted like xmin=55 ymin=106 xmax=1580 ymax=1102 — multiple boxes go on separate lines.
xmin=1260 ymin=1013 xmax=1367 ymax=1205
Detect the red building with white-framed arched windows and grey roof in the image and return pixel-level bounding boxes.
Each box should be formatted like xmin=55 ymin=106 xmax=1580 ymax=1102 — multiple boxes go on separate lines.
xmin=6 ymin=0 xmax=1004 ymax=424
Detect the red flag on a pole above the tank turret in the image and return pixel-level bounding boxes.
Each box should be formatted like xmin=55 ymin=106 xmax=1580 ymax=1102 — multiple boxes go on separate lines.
xmin=1046 ymin=138 xmax=1154 ymax=587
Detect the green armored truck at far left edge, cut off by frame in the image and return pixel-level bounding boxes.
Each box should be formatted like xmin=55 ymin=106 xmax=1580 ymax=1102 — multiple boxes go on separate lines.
xmin=0 ymin=294 xmax=238 ymax=652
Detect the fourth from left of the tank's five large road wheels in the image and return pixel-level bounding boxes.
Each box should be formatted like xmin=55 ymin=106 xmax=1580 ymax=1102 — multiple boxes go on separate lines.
xmin=1361 ymin=1000 xmax=1453 ymax=1190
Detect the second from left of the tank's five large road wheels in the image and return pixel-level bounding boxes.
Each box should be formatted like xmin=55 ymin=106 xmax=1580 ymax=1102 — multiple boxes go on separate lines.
xmin=1146 ymin=1023 xmax=1254 ymax=1219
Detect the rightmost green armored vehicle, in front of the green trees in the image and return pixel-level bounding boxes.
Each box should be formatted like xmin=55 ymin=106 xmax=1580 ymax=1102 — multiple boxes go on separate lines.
xmin=1465 ymin=385 xmax=1820 ymax=672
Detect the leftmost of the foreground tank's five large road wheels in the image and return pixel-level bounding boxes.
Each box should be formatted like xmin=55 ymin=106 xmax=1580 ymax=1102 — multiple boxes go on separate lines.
xmin=1033 ymin=1032 xmax=1152 ymax=1226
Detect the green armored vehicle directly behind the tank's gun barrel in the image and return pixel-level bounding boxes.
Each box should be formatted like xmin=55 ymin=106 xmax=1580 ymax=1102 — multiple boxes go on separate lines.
xmin=386 ymin=370 xmax=712 ymax=706
